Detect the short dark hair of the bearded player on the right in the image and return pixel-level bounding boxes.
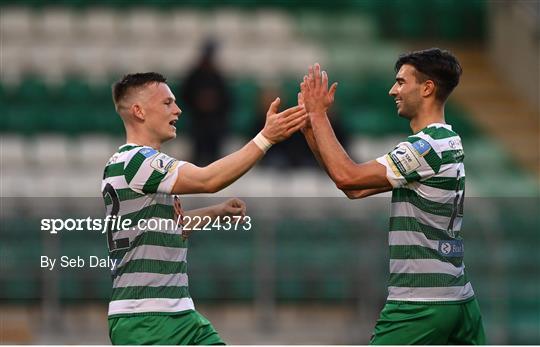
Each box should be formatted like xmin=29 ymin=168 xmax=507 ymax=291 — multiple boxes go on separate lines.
xmin=395 ymin=48 xmax=463 ymax=103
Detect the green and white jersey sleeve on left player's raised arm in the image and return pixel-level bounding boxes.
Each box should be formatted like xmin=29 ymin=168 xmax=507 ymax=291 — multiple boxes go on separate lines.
xmin=124 ymin=147 xmax=186 ymax=194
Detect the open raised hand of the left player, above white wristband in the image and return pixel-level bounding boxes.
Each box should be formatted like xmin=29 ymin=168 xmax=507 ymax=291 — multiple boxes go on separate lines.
xmin=262 ymin=98 xmax=307 ymax=143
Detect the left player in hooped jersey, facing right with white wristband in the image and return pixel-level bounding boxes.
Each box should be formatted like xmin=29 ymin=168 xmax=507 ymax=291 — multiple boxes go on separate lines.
xmin=102 ymin=72 xmax=307 ymax=345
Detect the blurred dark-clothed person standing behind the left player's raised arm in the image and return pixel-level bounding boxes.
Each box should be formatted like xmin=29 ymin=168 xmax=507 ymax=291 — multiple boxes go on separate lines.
xmin=181 ymin=39 xmax=232 ymax=165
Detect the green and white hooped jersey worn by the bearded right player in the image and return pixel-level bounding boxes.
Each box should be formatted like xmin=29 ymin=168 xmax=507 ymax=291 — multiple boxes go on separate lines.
xmin=377 ymin=124 xmax=474 ymax=302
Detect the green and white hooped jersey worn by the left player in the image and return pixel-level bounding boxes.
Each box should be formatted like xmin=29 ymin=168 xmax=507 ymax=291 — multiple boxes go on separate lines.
xmin=101 ymin=144 xmax=194 ymax=317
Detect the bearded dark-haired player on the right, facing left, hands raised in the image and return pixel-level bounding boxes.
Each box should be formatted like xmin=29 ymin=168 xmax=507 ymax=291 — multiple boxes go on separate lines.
xmin=299 ymin=48 xmax=485 ymax=345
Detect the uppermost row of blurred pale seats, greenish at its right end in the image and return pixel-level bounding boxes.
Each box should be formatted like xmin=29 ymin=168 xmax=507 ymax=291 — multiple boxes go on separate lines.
xmin=0 ymin=7 xmax=384 ymax=43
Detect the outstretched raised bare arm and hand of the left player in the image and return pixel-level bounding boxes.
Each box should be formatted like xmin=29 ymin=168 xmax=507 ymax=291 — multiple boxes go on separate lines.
xmin=171 ymin=98 xmax=307 ymax=194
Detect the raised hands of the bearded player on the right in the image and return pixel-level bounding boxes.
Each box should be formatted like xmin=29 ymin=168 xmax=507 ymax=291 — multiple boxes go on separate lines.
xmin=300 ymin=64 xmax=337 ymax=113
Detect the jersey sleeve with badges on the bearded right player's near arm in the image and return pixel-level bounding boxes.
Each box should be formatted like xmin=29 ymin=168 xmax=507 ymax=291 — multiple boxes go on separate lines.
xmin=376 ymin=136 xmax=442 ymax=188
